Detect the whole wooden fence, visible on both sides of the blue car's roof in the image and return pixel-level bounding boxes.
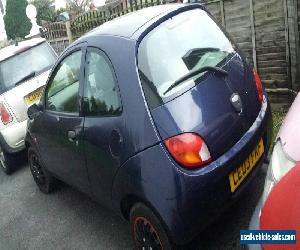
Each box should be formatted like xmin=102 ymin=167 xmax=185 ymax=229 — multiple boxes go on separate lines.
xmin=43 ymin=0 xmax=300 ymax=101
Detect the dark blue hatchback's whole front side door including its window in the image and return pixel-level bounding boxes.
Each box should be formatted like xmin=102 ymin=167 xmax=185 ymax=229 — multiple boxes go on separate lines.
xmin=38 ymin=47 xmax=90 ymax=193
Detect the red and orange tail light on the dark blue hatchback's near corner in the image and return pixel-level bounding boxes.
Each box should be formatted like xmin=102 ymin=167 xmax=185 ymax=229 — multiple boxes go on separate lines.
xmin=164 ymin=133 xmax=212 ymax=169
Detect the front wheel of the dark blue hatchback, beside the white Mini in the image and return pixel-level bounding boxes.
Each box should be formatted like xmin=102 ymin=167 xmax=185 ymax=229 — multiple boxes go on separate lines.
xmin=28 ymin=148 xmax=56 ymax=194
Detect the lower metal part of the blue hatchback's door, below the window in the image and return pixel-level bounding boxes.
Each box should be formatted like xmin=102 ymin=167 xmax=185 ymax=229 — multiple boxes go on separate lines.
xmin=43 ymin=113 xmax=90 ymax=194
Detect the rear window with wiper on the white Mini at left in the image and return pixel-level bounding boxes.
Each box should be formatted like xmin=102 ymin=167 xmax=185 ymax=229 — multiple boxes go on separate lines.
xmin=0 ymin=42 xmax=56 ymax=92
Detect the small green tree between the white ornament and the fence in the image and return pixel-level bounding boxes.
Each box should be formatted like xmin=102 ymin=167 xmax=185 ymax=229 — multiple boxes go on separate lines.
xmin=31 ymin=0 xmax=56 ymax=25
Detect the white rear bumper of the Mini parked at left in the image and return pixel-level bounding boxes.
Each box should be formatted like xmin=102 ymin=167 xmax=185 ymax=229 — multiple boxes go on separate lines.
xmin=0 ymin=120 xmax=27 ymax=153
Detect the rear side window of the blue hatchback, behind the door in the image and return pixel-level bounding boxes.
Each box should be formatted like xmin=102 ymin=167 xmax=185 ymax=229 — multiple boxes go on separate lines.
xmin=84 ymin=48 xmax=122 ymax=116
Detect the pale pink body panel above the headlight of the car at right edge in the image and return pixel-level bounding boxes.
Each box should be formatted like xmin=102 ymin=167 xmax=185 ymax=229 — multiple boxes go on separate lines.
xmin=278 ymin=94 xmax=300 ymax=161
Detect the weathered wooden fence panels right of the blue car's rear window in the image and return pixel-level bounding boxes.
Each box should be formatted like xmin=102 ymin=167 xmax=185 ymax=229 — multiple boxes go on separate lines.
xmin=203 ymin=0 xmax=300 ymax=102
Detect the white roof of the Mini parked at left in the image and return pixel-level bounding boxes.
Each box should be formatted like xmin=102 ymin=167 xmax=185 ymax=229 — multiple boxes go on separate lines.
xmin=0 ymin=38 xmax=46 ymax=62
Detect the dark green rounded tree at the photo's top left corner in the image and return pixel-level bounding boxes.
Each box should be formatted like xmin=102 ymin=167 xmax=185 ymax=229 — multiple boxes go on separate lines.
xmin=4 ymin=0 xmax=32 ymax=39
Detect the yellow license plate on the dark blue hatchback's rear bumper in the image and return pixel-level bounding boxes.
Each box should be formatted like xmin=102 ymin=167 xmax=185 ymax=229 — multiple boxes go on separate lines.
xmin=229 ymin=139 xmax=265 ymax=193
